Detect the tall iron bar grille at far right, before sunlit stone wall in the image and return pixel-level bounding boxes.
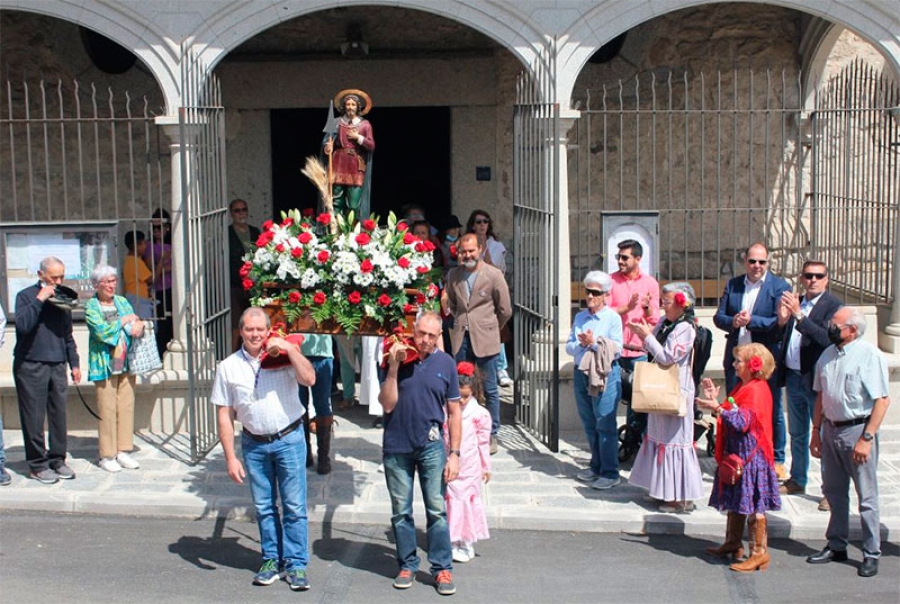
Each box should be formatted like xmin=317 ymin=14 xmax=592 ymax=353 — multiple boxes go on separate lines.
xmin=809 ymin=61 xmax=900 ymax=304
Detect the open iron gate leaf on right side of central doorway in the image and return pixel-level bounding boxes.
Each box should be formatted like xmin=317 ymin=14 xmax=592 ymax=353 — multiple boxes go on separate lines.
xmin=513 ymin=42 xmax=560 ymax=452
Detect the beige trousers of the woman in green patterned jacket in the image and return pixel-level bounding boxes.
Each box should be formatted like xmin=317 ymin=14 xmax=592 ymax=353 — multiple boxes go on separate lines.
xmin=94 ymin=374 xmax=134 ymax=459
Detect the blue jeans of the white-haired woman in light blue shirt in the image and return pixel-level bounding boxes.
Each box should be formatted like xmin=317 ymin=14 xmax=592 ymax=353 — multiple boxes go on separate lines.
xmin=575 ymin=365 xmax=622 ymax=478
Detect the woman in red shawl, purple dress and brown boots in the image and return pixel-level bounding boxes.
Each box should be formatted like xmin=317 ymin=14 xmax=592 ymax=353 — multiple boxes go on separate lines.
xmin=697 ymin=343 xmax=781 ymax=572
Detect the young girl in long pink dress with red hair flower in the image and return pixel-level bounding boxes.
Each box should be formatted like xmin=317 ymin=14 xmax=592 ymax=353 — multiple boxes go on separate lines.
xmin=444 ymin=363 xmax=491 ymax=562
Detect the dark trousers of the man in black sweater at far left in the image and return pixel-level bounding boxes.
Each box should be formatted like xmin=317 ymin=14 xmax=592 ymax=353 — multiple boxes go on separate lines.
xmin=13 ymin=360 xmax=68 ymax=472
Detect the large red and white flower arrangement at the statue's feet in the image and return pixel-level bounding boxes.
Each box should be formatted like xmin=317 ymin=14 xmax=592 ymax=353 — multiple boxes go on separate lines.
xmin=241 ymin=210 xmax=439 ymax=334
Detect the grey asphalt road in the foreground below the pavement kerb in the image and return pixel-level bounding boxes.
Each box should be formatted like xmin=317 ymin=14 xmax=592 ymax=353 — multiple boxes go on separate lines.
xmin=0 ymin=513 xmax=900 ymax=604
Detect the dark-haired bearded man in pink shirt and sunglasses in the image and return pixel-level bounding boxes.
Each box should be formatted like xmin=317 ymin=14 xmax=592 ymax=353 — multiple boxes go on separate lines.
xmin=609 ymin=239 xmax=659 ymax=432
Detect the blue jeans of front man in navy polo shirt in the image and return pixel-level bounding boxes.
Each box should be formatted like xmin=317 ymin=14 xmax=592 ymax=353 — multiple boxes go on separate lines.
xmin=384 ymin=439 xmax=453 ymax=575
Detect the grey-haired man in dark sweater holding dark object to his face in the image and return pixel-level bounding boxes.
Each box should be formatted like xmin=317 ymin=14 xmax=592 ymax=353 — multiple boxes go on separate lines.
xmin=13 ymin=256 xmax=81 ymax=484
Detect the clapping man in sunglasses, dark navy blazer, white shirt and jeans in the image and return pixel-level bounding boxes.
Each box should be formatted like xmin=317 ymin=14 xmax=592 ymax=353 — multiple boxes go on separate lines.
xmin=776 ymin=260 xmax=843 ymax=505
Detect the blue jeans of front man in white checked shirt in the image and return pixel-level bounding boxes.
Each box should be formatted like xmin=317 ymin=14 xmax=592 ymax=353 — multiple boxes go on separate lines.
xmin=241 ymin=429 xmax=309 ymax=570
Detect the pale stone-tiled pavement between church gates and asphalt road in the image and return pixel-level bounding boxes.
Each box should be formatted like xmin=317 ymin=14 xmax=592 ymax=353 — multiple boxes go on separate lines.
xmin=0 ymin=405 xmax=900 ymax=539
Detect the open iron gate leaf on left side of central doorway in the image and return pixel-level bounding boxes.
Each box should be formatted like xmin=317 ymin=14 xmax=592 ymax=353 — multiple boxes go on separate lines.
xmin=178 ymin=52 xmax=231 ymax=463
